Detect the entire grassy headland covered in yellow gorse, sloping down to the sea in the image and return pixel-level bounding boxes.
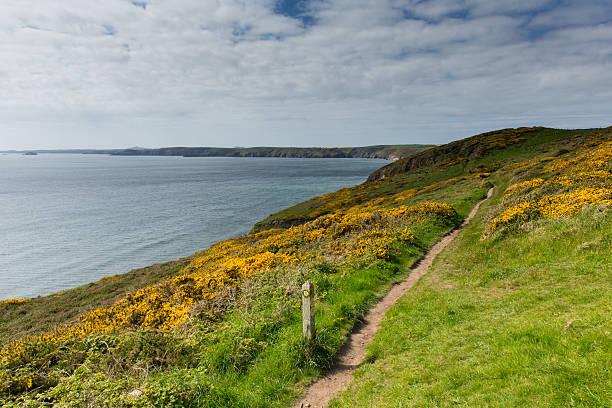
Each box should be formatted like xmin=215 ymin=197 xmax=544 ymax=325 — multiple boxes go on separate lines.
xmin=0 ymin=128 xmax=612 ymax=407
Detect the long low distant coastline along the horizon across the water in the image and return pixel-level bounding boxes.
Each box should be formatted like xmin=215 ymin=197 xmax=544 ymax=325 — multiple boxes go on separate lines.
xmin=0 ymin=144 xmax=435 ymax=160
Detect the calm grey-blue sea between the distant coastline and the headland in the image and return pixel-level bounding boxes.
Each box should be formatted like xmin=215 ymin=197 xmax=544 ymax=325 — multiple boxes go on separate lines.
xmin=0 ymin=154 xmax=386 ymax=300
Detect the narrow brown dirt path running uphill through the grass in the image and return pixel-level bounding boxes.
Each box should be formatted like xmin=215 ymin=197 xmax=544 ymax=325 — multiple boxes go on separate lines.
xmin=294 ymin=188 xmax=493 ymax=408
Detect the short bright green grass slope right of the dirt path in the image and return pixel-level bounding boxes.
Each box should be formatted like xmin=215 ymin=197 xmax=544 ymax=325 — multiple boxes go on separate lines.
xmin=330 ymin=179 xmax=612 ymax=408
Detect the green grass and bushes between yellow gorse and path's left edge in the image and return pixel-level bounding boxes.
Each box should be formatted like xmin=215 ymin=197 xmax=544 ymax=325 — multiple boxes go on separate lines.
xmin=4 ymin=200 xmax=483 ymax=407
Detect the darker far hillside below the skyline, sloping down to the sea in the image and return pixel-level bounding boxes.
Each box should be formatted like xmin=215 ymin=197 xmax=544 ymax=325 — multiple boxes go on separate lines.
xmin=253 ymin=128 xmax=592 ymax=231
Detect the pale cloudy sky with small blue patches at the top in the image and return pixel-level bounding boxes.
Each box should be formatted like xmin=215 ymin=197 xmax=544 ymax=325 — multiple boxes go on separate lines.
xmin=0 ymin=0 xmax=612 ymax=150
